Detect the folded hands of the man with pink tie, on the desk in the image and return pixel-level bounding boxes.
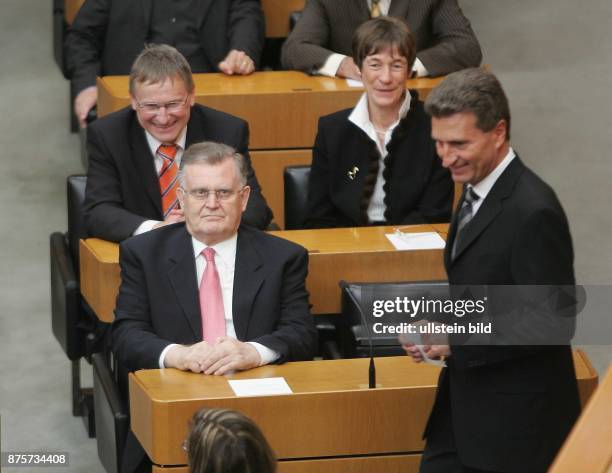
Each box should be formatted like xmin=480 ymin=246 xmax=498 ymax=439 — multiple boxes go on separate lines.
xmin=164 ymin=337 xmax=261 ymax=375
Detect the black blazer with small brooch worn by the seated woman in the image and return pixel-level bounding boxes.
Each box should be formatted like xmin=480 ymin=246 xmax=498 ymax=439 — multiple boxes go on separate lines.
xmin=305 ymin=96 xmax=454 ymax=228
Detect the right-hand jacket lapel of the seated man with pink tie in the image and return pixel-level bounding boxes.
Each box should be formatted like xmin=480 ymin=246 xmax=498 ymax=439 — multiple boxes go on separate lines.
xmin=232 ymin=229 xmax=265 ymax=340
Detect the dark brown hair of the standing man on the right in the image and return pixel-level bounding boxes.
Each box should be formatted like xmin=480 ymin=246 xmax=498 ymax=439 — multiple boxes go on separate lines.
xmin=425 ymin=68 xmax=510 ymax=139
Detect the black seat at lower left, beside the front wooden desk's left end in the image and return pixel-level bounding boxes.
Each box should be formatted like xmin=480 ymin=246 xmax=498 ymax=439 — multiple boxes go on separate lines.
xmin=91 ymin=353 xmax=130 ymax=473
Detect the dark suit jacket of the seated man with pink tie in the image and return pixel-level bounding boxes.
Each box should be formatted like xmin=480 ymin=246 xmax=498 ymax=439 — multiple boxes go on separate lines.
xmin=112 ymin=223 xmax=317 ymax=472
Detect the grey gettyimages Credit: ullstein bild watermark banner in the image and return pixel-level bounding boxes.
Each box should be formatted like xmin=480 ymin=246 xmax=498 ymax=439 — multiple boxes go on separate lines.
xmin=360 ymin=283 xmax=612 ymax=345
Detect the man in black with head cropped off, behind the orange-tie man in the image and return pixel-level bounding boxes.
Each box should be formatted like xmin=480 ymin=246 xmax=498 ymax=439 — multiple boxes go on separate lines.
xmin=65 ymin=0 xmax=264 ymax=126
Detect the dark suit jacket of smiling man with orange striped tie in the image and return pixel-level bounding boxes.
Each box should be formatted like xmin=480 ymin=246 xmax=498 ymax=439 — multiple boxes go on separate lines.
xmin=84 ymin=104 xmax=272 ymax=241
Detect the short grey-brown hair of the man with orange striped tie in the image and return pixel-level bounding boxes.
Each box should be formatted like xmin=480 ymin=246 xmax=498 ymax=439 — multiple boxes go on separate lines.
xmin=129 ymin=44 xmax=195 ymax=96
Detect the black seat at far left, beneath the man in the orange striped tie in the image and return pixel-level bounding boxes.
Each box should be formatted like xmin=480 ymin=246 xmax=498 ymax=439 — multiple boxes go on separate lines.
xmin=49 ymin=176 xmax=108 ymax=437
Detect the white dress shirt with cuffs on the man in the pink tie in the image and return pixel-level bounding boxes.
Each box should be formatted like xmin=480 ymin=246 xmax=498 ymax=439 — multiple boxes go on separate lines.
xmin=159 ymin=234 xmax=280 ymax=368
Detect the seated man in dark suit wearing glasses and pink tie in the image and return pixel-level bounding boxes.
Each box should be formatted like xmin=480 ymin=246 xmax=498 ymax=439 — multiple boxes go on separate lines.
xmin=112 ymin=142 xmax=317 ymax=471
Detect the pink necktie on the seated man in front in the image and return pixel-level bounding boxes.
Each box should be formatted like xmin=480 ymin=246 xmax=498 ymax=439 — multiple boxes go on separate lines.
xmin=200 ymin=247 xmax=225 ymax=343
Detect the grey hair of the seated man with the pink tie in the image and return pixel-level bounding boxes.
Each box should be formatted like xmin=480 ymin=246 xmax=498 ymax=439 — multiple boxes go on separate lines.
xmin=178 ymin=141 xmax=249 ymax=186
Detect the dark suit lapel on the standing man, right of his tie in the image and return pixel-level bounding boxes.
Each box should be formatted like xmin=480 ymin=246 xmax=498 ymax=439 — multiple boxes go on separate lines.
xmin=449 ymin=156 xmax=525 ymax=264
